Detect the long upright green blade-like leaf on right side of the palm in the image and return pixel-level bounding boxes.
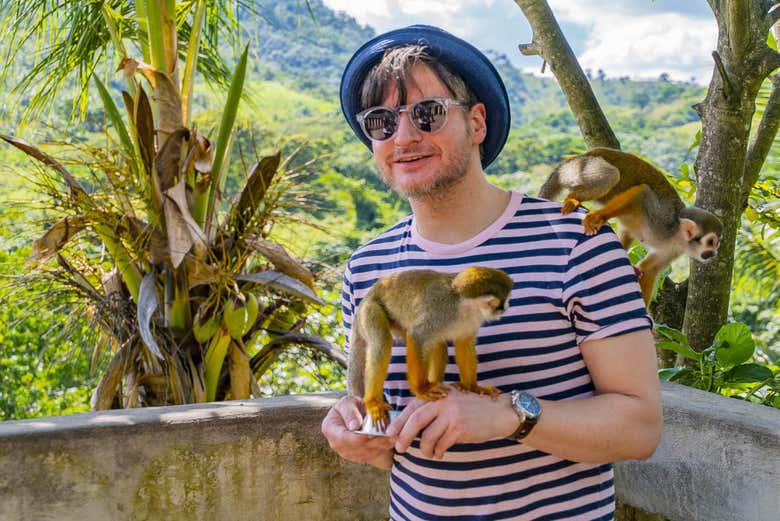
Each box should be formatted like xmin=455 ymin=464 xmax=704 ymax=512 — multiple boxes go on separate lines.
xmin=203 ymin=45 xmax=249 ymax=235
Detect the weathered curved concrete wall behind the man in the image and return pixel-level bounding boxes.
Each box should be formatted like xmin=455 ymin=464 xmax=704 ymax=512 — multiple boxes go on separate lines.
xmin=0 ymin=384 xmax=780 ymax=521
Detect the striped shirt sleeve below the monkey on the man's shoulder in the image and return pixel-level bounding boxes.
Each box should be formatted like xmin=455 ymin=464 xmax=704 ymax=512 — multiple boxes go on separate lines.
xmin=563 ymin=226 xmax=653 ymax=344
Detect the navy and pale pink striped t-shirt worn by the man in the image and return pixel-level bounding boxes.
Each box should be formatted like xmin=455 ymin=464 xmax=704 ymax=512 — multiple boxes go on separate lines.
xmin=343 ymin=193 xmax=652 ymax=521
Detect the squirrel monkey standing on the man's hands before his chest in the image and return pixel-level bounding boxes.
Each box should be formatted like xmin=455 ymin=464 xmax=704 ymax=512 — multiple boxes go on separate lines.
xmin=347 ymin=267 xmax=513 ymax=431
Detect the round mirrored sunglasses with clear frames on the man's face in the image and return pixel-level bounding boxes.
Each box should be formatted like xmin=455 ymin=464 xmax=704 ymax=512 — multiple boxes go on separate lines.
xmin=356 ymin=98 xmax=468 ymax=141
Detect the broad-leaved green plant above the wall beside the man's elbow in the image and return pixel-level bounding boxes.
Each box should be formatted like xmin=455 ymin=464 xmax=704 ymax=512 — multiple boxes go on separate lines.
xmin=656 ymin=322 xmax=780 ymax=409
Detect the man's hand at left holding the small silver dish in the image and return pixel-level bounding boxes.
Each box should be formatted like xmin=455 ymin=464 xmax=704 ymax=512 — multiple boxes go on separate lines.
xmin=322 ymin=396 xmax=395 ymax=469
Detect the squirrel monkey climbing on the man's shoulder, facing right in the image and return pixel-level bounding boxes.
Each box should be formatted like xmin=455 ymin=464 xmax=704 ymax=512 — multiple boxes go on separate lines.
xmin=539 ymin=148 xmax=723 ymax=306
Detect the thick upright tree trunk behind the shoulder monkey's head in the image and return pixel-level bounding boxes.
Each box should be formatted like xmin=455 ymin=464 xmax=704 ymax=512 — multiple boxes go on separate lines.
xmin=683 ymin=0 xmax=780 ymax=350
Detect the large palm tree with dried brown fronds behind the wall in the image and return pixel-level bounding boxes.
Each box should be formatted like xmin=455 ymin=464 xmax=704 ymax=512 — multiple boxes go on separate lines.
xmin=0 ymin=0 xmax=344 ymax=409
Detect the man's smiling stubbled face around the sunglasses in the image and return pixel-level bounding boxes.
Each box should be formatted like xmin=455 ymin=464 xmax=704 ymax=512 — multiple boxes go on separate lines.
xmin=372 ymin=64 xmax=485 ymax=199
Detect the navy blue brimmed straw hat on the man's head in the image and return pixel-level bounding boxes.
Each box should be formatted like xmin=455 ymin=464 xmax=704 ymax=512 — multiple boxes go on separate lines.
xmin=339 ymin=25 xmax=509 ymax=168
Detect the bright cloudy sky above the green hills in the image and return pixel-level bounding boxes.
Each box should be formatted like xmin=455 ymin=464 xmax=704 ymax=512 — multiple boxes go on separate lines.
xmin=323 ymin=0 xmax=717 ymax=85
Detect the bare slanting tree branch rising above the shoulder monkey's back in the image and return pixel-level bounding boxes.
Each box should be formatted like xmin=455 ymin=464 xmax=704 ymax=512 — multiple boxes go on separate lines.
xmin=515 ymin=0 xmax=620 ymax=148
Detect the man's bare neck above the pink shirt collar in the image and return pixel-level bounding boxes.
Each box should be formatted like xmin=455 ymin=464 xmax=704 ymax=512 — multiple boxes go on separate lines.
xmin=410 ymin=171 xmax=511 ymax=244
